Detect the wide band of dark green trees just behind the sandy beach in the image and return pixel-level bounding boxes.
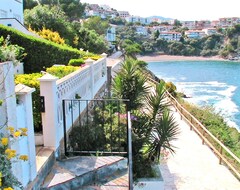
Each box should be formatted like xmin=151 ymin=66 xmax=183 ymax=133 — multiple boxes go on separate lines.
xmin=117 ymin=21 xmax=240 ymax=57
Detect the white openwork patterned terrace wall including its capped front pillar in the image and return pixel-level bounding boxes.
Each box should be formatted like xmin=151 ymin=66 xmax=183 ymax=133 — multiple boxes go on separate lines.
xmin=39 ymin=55 xmax=107 ymax=156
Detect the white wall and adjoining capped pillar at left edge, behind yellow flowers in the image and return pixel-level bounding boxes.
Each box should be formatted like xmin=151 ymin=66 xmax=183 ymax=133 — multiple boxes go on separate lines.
xmin=0 ymin=62 xmax=36 ymax=186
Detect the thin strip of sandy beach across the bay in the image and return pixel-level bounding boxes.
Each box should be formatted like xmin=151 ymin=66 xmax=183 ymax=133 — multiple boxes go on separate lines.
xmin=137 ymin=55 xmax=226 ymax=62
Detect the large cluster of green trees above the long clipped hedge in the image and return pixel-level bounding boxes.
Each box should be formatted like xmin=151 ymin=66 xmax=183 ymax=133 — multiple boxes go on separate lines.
xmin=24 ymin=3 xmax=109 ymax=54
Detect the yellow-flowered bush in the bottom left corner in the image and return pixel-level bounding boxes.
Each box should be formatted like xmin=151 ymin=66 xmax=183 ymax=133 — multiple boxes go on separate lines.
xmin=0 ymin=127 xmax=28 ymax=190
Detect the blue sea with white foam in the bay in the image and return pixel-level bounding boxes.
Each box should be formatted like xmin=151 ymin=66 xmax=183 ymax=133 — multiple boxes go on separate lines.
xmin=148 ymin=61 xmax=240 ymax=130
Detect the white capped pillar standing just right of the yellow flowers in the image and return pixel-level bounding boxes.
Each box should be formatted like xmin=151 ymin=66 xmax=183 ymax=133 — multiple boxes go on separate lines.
xmin=15 ymin=84 xmax=37 ymax=181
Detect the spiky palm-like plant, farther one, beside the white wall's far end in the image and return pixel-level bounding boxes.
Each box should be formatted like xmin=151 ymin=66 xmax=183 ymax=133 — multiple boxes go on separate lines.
xmin=113 ymin=58 xmax=149 ymax=110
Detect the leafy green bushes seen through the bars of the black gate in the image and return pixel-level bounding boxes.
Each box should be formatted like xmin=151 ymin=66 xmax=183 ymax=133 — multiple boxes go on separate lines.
xmin=69 ymin=101 xmax=127 ymax=152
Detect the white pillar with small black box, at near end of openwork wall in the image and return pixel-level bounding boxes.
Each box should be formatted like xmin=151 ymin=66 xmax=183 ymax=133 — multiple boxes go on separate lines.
xmin=38 ymin=73 xmax=59 ymax=150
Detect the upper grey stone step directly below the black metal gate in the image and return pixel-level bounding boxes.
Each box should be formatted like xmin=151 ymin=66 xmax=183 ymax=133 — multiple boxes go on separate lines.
xmin=41 ymin=156 xmax=127 ymax=190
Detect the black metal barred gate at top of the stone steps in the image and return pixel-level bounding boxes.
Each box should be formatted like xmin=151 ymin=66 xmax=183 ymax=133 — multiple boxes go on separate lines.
xmin=63 ymin=99 xmax=128 ymax=156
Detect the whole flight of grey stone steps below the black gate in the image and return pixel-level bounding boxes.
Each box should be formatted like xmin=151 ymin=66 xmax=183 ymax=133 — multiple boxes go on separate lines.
xmin=41 ymin=156 xmax=129 ymax=190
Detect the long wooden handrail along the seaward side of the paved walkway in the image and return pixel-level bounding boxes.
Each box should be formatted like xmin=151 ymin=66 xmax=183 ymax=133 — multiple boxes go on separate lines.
xmin=148 ymin=78 xmax=240 ymax=179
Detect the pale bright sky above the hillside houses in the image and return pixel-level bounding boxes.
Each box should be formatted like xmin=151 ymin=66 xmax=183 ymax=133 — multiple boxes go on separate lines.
xmin=80 ymin=0 xmax=240 ymax=21
